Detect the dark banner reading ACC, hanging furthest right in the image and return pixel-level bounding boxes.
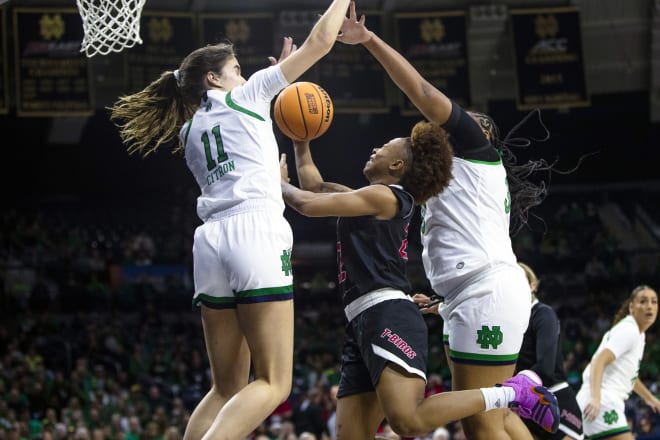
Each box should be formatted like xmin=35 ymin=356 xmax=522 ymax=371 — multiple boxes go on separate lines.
xmin=510 ymin=7 xmax=590 ymax=110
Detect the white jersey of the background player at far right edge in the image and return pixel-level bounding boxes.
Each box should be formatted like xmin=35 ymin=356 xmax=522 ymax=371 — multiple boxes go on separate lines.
xmin=580 ymin=315 xmax=646 ymax=399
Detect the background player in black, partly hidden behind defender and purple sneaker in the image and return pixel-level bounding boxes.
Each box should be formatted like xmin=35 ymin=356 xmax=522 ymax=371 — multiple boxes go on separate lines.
xmin=504 ymin=263 xmax=584 ymax=440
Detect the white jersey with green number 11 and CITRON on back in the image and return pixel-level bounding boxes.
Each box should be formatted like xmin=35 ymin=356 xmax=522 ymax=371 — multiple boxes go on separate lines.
xmin=180 ymin=65 xmax=288 ymax=221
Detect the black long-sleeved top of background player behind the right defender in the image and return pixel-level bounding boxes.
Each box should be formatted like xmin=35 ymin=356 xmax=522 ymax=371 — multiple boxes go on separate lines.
xmin=516 ymin=302 xmax=566 ymax=387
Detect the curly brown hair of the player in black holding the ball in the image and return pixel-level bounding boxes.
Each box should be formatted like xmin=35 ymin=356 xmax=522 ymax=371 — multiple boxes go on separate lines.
xmin=401 ymin=121 xmax=454 ymax=205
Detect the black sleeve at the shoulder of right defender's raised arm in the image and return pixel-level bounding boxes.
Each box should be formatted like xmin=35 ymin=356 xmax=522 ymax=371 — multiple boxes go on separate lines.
xmin=442 ymin=101 xmax=500 ymax=162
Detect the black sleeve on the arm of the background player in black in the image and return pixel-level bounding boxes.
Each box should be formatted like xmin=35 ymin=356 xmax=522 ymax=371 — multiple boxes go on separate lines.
xmin=532 ymin=305 xmax=559 ymax=378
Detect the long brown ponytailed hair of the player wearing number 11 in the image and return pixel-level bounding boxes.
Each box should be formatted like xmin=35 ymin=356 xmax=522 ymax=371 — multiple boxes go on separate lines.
xmin=109 ymin=42 xmax=235 ymax=156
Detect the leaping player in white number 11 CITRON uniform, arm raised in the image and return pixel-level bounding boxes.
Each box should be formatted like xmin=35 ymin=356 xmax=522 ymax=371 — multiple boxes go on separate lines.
xmin=111 ymin=0 xmax=349 ymax=440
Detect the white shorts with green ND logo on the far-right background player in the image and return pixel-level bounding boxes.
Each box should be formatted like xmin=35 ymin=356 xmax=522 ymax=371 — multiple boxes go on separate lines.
xmin=575 ymin=386 xmax=630 ymax=438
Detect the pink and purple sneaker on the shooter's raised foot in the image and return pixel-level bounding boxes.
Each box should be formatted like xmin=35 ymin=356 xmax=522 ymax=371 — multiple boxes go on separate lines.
xmin=502 ymin=370 xmax=559 ymax=434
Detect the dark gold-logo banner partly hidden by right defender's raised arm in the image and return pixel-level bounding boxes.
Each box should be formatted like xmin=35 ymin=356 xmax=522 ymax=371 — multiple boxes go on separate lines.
xmin=394 ymin=11 xmax=471 ymax=115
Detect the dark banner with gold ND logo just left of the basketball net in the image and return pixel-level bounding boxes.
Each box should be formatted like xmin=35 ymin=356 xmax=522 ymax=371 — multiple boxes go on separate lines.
xmin=13 ymin=8 xmax=94 ymax=116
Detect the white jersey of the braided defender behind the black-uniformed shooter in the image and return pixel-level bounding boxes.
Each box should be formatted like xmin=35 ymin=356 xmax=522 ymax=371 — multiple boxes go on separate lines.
xmin=421 ymin=157 xmax=517 ymax=297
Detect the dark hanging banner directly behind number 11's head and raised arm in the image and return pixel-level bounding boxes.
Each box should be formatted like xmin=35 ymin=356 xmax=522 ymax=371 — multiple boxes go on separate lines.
xmin=199 ymin=13 xmax=282 ymax=78
